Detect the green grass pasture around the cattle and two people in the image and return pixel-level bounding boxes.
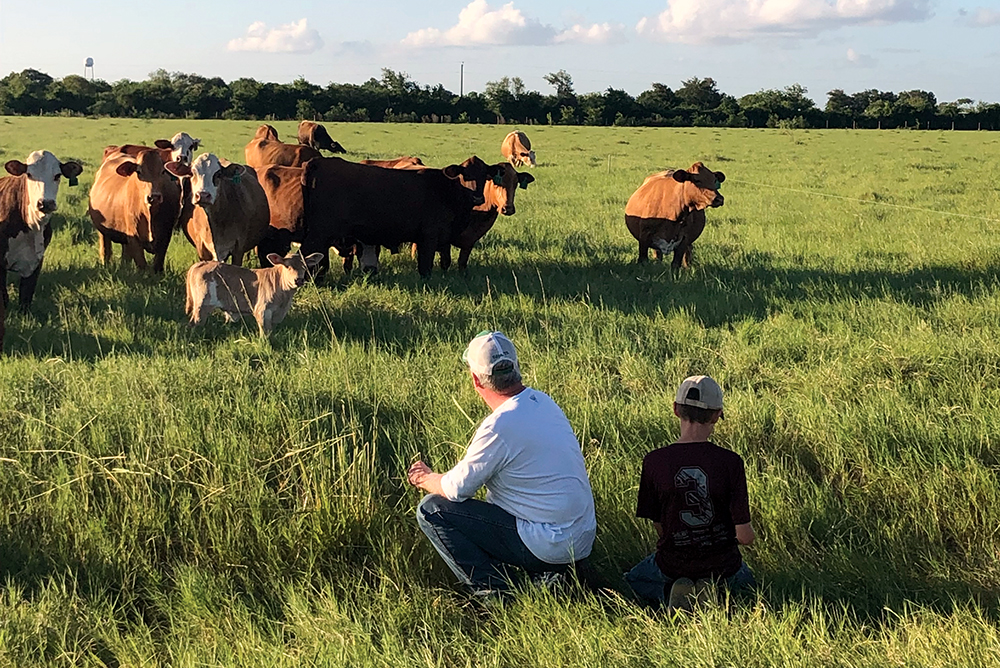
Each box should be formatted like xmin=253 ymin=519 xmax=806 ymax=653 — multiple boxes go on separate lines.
xmin=0 ymin=118 xmax=1000 ymax=668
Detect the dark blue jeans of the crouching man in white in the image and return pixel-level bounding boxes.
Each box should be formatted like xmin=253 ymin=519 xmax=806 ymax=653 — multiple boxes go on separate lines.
xmin=417 ymin=494 xmax=568 ymax=592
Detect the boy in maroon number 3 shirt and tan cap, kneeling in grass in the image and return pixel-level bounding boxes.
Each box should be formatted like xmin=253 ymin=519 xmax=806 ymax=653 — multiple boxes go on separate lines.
xmin=625 ymin=376 xmax=755 ymax=609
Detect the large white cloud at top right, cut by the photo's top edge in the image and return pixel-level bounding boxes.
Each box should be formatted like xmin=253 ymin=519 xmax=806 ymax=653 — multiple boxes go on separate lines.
xmin=636 ymin=0 xmax=930 ymax=44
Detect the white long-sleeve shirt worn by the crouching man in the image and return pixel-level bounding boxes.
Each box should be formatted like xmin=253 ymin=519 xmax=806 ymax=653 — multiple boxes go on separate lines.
xmin=441 ymin=387 xmax=597 ymax=564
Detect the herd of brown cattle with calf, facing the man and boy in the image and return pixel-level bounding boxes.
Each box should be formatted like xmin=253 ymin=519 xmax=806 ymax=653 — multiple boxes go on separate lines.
xmin=0 ymin=121 xmax=725 ymax=352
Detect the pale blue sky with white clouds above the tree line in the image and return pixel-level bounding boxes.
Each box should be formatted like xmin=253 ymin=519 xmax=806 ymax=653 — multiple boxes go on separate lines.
xmin=0 ymin=0 xmax=1000 ymax=105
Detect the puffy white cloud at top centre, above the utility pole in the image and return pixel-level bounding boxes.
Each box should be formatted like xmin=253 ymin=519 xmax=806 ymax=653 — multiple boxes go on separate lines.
xmin=403 ymin=0 xmax=625 ymax=47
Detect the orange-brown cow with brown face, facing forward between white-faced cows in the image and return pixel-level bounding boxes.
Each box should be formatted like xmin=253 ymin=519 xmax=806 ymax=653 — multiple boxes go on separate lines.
xmin=87 ymin=151 xmax=181 ymax=273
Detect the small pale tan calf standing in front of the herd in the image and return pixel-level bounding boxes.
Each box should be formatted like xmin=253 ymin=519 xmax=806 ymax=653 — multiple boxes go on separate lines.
xmin=184 ymin=253 xmax=323 ymax=336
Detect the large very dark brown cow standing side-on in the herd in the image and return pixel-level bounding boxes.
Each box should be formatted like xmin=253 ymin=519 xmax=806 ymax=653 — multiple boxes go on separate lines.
xmin=302 ymin=158 xmax=499 ymax=277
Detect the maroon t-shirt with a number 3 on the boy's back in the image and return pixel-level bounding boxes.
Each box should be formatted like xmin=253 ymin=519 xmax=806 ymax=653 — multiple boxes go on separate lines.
xmin=636 ymin=442 xmax=750 ymax=579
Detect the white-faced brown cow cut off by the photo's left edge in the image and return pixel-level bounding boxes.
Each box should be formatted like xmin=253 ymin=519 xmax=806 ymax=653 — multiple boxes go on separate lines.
xmin=0 ymin=151 xmax=83 ymax=352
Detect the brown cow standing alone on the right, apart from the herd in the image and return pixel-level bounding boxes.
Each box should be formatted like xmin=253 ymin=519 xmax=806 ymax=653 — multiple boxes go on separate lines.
xmin=625 ymin=162 xmax=726 ymax=269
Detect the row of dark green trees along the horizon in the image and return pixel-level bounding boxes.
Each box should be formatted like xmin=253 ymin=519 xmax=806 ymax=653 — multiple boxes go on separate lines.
xmin=0 ymin=69 xmax=1000 ymax=130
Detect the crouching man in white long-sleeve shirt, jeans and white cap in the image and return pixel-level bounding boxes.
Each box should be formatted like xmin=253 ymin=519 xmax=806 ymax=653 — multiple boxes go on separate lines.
xmin=407 ymin=332 xmax=597 ymax=595
